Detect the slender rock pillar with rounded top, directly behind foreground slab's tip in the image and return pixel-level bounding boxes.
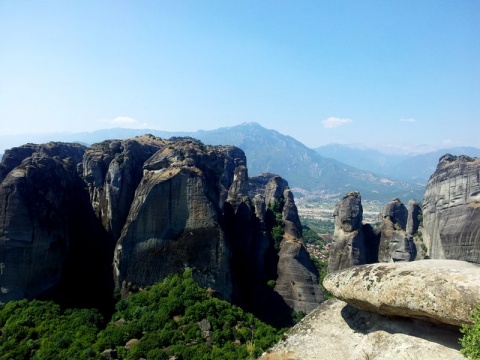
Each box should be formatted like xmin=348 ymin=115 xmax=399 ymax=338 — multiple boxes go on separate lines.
xmin=328 ymin=192 xmax=367 ymax=272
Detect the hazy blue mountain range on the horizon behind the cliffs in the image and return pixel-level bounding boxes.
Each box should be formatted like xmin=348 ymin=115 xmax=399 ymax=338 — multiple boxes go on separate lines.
xmin=0 ymin=123 xmax=480 ymax=203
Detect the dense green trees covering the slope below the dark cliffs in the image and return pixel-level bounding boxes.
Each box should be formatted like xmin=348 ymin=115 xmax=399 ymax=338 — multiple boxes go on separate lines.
xmin=0 ymin=269 xmax=285 ymax=360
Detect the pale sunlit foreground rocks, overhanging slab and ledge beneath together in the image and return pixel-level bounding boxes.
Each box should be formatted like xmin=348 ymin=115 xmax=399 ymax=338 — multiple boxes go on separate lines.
xmin=260 ymin=260 xmax=480 ymax=360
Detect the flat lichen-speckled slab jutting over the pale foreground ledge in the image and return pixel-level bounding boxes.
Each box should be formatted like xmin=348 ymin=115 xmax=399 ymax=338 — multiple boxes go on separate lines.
xmin=323 ymin=260 xmax=480 ymax=326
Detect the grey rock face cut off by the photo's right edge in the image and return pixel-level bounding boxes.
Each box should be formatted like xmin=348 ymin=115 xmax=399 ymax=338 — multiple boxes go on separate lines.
xmin=423 ymin=154 xmax=480 ymax=264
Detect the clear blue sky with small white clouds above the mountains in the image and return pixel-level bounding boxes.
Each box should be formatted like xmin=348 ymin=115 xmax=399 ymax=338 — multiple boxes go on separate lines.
xmin=0 ymin=0 xmax=480 ymax=147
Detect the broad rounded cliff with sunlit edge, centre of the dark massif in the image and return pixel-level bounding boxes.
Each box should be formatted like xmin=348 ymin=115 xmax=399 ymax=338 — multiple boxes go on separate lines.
xmin=114 ymin=139 xmax=245 ymax=299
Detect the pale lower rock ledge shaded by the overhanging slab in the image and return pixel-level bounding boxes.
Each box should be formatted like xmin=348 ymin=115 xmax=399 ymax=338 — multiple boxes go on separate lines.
xmin=260 ymin=299 xmax=465 ymax=360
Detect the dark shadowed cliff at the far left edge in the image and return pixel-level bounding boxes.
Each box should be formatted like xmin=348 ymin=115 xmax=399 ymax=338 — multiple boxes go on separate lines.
xmin=0 ymin=143 xmax=113 ymax=302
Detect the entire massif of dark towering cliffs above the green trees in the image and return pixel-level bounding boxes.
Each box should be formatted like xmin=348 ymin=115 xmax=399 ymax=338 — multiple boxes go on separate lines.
xmin=0 ymin=135 xmax=323 ymax=316
